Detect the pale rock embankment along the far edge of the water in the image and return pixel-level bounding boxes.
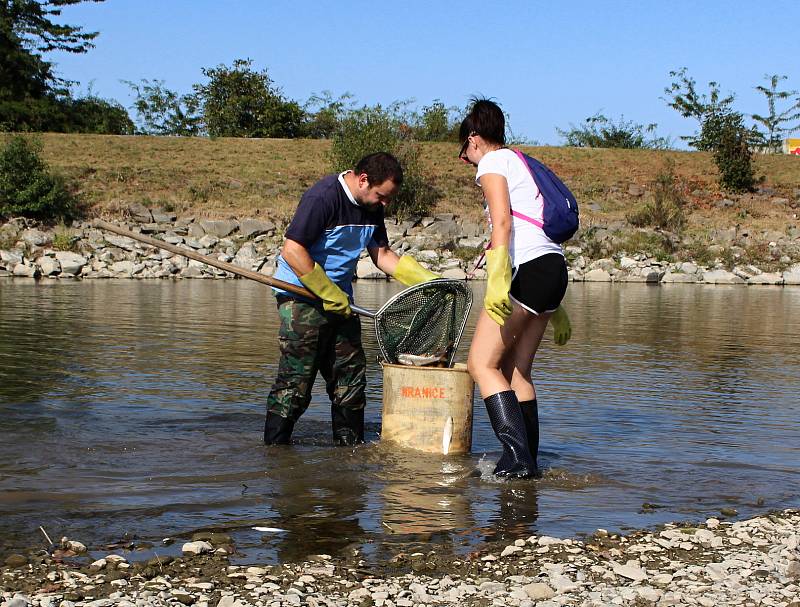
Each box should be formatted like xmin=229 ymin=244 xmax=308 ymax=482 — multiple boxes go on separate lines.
xmin=0 ymin=205 xmax=800 ymax=285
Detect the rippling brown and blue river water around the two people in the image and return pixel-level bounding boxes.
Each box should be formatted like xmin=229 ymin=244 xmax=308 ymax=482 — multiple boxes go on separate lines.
xmin=0 ymin=280 xmax=800 ymax=562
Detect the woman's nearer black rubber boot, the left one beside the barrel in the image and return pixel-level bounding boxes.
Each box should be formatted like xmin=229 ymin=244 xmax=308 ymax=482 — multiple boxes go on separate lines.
xmin=483 ymin=390 xmax=537 ymax=478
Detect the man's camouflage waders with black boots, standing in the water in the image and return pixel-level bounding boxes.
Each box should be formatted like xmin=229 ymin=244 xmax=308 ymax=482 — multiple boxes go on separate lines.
xmin=264 ymin=296 xmax=366 ymax=445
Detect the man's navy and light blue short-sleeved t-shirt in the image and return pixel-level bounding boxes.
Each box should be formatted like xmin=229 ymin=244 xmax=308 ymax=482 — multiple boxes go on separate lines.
xmin=274 ymin=175 xmax=389 ymax=297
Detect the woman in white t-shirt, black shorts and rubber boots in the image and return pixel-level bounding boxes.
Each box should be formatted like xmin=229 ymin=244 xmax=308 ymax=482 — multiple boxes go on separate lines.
xmin=458 ymin=99 xmax=571 ymax=478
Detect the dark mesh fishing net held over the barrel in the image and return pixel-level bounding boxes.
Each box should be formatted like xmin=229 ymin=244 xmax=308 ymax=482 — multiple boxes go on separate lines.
xmin=375 ymin=278 xmax=472 ymax=367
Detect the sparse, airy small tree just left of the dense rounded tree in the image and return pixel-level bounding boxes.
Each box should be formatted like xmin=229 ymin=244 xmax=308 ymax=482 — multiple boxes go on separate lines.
xmin=123 ymin=79 xmax=202 ymax=136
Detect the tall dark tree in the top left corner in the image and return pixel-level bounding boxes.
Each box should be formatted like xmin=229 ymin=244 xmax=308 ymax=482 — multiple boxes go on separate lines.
xmin=0 ymin=0 xmax=103 ymax=130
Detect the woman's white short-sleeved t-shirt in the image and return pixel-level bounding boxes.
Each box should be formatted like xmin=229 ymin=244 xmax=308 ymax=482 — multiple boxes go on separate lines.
xmin=475 ymin=148 xmax=564 ymax=268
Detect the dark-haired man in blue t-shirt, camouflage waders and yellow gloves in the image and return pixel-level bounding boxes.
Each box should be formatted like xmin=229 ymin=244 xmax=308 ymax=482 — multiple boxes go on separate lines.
xmin=264 ymin=152 xmax=438 ymax=445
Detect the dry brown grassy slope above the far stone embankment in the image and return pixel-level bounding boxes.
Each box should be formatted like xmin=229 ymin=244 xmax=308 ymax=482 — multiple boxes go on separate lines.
xmin=18 ymin=134 xmax=800 ymax=238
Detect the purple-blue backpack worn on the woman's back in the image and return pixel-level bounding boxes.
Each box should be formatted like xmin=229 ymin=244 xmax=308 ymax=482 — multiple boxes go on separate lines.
xmin=511 ymin=150 xmax=578 ymax=244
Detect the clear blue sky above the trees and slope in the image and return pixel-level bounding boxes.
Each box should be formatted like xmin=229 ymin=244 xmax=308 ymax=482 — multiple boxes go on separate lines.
xmin=49 ymin=0 xmax=800 ymax=144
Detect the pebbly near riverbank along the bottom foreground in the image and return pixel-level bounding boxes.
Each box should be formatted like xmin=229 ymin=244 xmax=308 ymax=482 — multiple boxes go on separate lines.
xmin=0 ymin=510 xmax=800 ymax=607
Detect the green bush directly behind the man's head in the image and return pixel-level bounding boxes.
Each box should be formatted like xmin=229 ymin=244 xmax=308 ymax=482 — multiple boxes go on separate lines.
xmin=331 ymin=105 xmax=439 ymax=218
